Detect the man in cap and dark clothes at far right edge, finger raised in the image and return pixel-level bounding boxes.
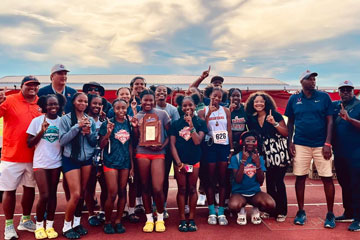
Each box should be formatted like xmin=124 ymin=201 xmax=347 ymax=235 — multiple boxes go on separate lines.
xmin=333 ymin=80 xmax=360 ymax=231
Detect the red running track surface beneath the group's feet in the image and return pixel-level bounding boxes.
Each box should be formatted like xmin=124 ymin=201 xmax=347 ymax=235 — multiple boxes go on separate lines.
xmin=0 ymin=176 xmax=360 ymax=240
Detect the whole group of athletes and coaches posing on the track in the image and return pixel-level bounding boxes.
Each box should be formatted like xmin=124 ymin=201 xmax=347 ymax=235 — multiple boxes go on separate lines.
xmin=0 ymin=64 xmax=360 ymax=239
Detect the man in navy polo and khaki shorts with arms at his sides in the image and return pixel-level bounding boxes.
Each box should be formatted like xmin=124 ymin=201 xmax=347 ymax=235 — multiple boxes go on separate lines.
xmin=285 ymin=70 xmax=335 ymax=228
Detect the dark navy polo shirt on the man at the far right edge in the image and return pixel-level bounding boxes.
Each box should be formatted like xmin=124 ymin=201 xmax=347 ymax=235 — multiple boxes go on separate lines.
xmin=333 ymin=97 xmax=360 ymax=167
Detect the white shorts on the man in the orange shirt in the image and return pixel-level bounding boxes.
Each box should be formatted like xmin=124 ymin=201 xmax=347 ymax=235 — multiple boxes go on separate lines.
xmin=0 ymin=161 xmax=36 ymax=191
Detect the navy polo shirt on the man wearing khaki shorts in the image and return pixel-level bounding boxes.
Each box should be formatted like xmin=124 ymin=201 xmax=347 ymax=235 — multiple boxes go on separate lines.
xmin=285 ymin=90 xmax=334 ymax=147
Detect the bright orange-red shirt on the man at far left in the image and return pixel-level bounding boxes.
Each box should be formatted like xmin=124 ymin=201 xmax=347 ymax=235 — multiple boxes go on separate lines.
xmin=0 ymin=92 xmax=41 ymax=163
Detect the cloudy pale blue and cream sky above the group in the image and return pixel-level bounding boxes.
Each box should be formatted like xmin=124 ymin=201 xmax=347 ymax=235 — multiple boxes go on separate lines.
xmin=0 ymin=0 xmax=360 ymax=86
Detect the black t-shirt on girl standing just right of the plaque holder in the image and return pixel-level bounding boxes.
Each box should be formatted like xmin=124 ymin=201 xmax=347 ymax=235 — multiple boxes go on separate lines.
xmin=170 ymin=116 xmax=208 ymax=165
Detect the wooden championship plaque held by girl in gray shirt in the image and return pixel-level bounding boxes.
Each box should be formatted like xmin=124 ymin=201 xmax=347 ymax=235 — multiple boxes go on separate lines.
xmin=139 ymin=113 xmax=162 ymax=147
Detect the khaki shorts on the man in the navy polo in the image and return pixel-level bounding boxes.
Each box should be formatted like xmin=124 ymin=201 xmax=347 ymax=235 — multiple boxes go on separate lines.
xmin=293 ymin=145 xmax=333 ymax=177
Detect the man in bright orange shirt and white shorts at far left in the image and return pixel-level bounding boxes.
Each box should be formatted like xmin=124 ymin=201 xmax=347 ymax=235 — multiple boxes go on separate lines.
xmin=0 ymin=76 xmax=41 ymax=239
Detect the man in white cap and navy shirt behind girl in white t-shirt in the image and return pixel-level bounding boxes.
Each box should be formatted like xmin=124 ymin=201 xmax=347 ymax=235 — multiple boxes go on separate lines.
xmin=38 ymin=64 xmax=77 ymax=116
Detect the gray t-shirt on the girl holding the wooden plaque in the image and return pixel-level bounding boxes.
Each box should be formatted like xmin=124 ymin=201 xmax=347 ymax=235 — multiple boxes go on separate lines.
xmin=135 ymin=108 xmax=171 ymax=155
